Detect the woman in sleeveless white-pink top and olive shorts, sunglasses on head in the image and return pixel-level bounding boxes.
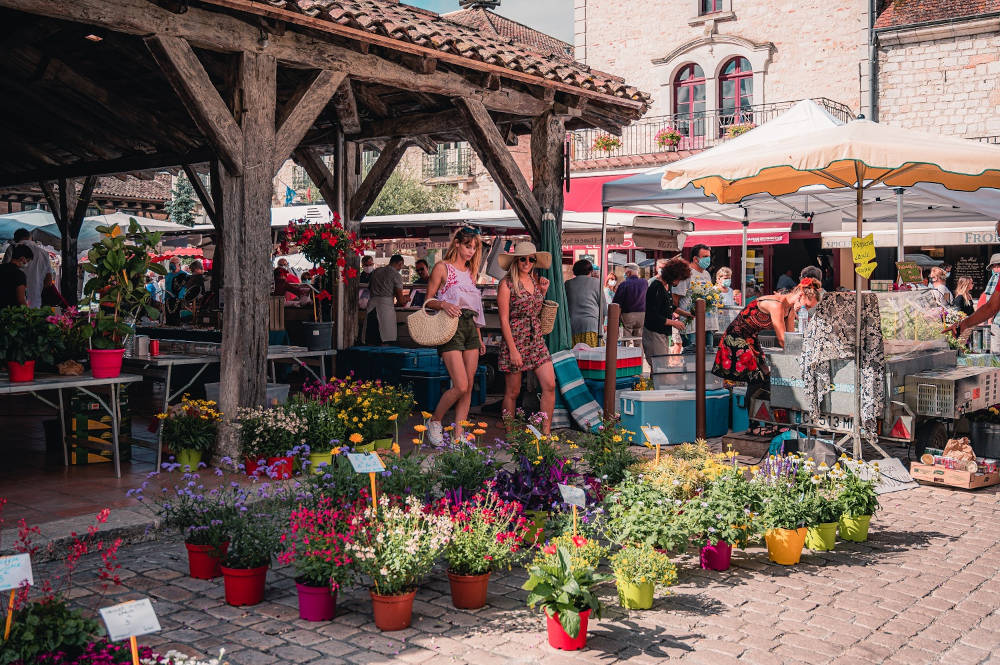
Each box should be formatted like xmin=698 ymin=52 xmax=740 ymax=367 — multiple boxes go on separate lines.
xmin=426 ymin=226 xmax=486 ymax=445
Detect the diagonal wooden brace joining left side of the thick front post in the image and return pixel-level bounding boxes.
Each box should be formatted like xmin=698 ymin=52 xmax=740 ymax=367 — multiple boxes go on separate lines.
xmin=145 ymin=35 xmax=243 ymax=175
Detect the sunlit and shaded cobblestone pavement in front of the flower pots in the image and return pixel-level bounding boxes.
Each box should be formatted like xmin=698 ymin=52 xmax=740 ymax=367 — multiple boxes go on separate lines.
xmin=52 ymin=480 xmax=1000 ymax=665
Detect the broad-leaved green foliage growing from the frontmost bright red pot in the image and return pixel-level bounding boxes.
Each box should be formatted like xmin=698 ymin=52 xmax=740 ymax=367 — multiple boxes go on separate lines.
xmin=521 ymin=536 xmax=610 ymax=638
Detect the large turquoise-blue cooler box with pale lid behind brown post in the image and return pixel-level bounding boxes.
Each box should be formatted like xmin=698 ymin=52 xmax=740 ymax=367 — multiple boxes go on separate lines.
xmin=619 ymin=390 xmax=729 ymax=444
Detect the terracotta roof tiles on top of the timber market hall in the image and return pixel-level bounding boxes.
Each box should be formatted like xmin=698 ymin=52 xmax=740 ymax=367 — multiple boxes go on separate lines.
xmin=258 ymin=0 xmax=650 ymax=105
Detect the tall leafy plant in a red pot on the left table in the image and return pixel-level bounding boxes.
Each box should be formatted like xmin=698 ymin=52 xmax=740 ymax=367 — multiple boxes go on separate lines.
xmin=81 ymin=217 xmax=167 ymax=379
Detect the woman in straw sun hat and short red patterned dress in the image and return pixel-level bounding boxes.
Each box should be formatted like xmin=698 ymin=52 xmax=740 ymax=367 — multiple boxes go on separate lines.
xmin=497 ymin=242 xmax=556 ymax=434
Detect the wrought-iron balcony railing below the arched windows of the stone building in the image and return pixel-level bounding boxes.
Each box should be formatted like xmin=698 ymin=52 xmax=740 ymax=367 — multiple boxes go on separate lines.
xmin=572 ymin=97 xmax=854 ymax=161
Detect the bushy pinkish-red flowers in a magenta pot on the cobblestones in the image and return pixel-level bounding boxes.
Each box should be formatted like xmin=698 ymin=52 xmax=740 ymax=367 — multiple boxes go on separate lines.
xmin=278 ymin=497 xmax=355 ymax=621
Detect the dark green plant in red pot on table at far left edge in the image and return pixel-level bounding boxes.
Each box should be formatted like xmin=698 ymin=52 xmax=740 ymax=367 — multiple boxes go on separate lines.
xmin=0 ymin=305 xmax=59 ymax=383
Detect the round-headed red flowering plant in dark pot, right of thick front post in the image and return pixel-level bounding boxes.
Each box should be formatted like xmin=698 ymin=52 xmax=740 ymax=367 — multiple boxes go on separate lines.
xmin=281 ymin=218 xmax=365 ymax=350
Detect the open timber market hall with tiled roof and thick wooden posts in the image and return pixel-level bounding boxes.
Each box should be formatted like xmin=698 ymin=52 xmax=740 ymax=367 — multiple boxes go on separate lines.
xmin=0 ymin=0 xmax=650 ymax=451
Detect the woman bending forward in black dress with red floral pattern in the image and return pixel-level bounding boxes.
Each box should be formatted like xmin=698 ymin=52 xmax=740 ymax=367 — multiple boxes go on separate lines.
xmin=712 ymin=277 xmax=822 ymax=398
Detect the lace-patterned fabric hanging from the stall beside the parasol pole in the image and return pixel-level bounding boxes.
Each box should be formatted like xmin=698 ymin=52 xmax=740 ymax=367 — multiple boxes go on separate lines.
xmin=799 ymin=293 xmax=885 ymax=441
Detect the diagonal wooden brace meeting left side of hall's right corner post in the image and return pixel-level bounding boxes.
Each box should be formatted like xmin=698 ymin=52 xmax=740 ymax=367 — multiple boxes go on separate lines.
xmin=455 ymin=97 xmax=542 ymax=243
